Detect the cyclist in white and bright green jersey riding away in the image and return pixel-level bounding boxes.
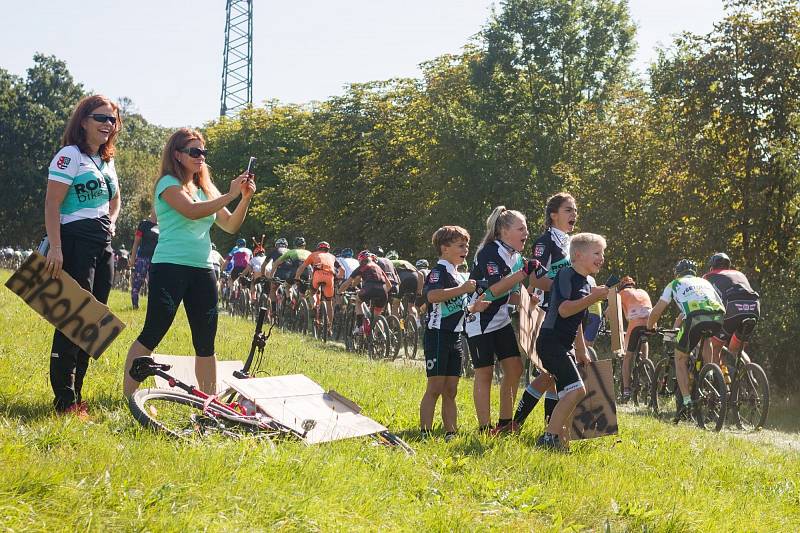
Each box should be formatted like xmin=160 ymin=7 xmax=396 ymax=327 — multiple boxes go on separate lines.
xmin=647 ymin=259 xmax=725 ymax=421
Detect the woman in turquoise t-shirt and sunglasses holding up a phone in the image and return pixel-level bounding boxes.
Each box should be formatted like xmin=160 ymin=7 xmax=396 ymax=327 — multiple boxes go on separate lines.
xmin=123 ymin=128 xmax=256 ymax=397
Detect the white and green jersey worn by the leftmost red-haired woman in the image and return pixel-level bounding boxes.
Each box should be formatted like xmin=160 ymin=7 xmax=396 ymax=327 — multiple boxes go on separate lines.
xmin=47 ymin=145 xmax=119 ymax=224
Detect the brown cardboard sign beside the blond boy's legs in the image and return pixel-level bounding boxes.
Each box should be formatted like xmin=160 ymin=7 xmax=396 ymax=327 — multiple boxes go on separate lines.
xmin=570 ymin=359 xmax=618 ymax=440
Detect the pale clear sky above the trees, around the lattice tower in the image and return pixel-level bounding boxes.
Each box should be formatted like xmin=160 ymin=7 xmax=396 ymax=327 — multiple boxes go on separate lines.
xmin=0 ymin=0 xmax=723 ymax=126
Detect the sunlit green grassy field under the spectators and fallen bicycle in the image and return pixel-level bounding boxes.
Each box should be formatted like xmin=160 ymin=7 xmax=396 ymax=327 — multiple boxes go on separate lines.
xmin=0 ymin=272 xmax=800 ymax=531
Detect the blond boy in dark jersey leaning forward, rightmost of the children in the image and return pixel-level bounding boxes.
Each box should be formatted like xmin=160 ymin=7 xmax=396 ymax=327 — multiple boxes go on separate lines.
xmin=536 ymin=233 xmax=608 ymax=449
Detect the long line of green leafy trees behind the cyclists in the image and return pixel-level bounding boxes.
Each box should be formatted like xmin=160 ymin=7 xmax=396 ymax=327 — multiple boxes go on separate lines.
xmin=0 ymin=0 xmax=800 ymax=385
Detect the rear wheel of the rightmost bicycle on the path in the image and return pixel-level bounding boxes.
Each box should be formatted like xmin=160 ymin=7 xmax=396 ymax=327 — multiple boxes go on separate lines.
xmin=730 ymin=363 xmax=769 ymax=431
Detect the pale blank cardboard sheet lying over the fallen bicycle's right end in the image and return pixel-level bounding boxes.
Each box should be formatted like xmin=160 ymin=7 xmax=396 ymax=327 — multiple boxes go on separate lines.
xmin=226 ymin=374 xmax=386 ymax=444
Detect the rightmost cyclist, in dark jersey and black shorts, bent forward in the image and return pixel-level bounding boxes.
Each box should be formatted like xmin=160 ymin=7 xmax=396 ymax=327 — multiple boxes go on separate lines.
xmin=703 ymin=252 xmax=761 ymax=364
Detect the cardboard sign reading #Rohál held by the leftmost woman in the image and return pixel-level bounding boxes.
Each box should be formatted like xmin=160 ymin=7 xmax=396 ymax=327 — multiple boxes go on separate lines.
xmin=6 ymin=252 xmax=125 ymax=359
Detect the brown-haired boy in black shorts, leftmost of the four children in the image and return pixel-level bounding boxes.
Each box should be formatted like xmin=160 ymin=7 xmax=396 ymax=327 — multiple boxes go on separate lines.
xmin=419 ymin=226 xmax=489 ymax=440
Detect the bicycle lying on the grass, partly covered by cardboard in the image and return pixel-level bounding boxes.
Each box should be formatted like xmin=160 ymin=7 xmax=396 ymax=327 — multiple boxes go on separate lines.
xmin=128 ymin=308 xmax=414 ymax=454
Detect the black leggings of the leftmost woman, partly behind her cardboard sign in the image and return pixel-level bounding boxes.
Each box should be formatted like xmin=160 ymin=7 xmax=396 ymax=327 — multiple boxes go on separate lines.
xmin=50 ymin=235 xmax=114 ymax=411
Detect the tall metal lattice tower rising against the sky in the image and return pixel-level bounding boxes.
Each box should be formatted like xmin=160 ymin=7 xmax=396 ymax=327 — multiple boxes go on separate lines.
xmin=219 ymin=0 xmax=253 ymax=117
